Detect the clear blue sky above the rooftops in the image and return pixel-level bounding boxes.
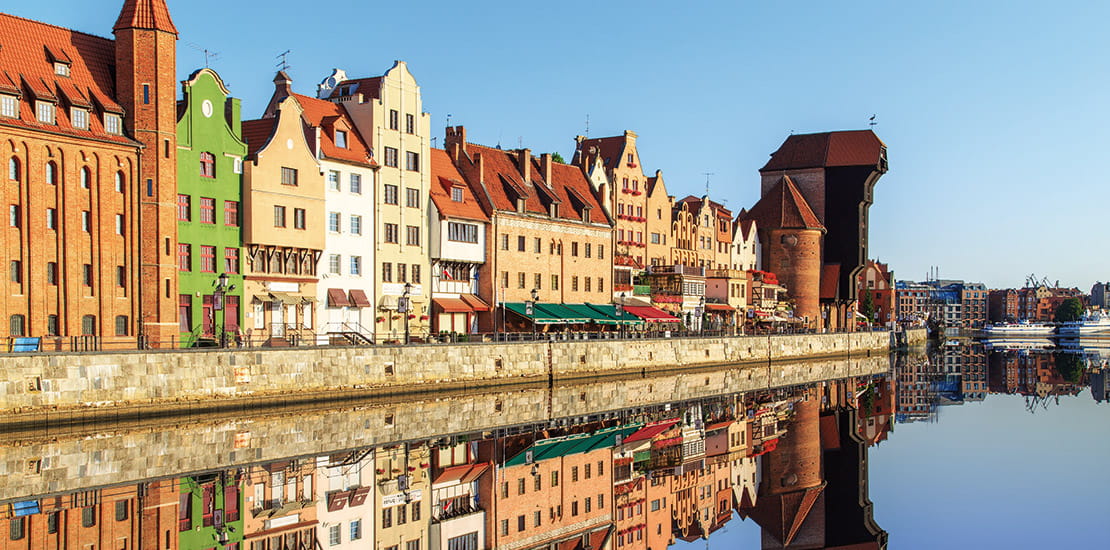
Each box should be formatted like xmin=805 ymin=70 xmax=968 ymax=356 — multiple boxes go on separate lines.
xmin=17 ymin=0 xmax=1110 ymax=291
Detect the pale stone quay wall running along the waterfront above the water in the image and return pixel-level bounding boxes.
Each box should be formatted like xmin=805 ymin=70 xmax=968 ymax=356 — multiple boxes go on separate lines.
xmin=0 ymin=332 xmax=919 ymax=414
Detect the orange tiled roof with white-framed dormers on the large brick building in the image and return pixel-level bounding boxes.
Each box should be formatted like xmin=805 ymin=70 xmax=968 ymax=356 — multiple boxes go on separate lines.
xmin=0 ymin=13 xmax=138 ymax=146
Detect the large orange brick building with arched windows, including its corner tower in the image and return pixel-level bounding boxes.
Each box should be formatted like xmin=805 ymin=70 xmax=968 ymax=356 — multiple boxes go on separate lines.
xmin=0 ymin=0 xmax=178 ymax=347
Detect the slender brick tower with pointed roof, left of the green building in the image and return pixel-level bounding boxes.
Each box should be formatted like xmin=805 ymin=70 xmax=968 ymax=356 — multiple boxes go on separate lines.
xmin=113 ymin=0 xmax=178 ymax=347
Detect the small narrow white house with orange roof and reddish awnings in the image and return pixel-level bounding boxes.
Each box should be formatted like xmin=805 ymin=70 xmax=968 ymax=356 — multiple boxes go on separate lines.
xmin=428 ymin=149 xmax=491 ymax=333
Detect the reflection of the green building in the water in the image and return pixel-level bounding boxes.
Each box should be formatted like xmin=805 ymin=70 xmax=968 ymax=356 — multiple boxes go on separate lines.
xmin=178 ymin=470 xmax=243 ymax=550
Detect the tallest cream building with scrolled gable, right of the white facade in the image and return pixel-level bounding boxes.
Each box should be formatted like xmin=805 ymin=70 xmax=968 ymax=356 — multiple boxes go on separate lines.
xmin=317 ymin=61 xmax=432 ymax=338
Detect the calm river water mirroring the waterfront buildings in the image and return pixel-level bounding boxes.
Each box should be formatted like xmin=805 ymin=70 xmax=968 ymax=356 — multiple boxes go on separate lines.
xmin=0 ymin=341 xmax=1110 ymax=550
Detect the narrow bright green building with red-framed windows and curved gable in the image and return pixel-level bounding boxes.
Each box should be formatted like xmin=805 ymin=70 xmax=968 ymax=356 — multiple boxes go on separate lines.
xmin=176 ymin=69 xmax=246 ymax=346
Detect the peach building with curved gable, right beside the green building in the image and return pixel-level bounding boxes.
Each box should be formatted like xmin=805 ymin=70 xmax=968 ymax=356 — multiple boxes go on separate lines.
xmin=243 ymin=93 xmax=324 ymax=346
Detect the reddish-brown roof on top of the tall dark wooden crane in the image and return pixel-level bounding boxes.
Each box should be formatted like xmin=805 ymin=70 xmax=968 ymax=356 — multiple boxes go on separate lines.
xmin=759 ymin=130 xmax=886 ymax=172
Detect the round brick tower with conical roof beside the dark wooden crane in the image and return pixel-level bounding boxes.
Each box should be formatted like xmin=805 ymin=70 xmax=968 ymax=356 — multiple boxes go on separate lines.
xmin=740 ymin=176 xmax=825 ymax=327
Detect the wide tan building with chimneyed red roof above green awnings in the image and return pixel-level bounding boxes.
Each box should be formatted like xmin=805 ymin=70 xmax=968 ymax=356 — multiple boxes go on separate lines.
xmin=446 ymin=127 xmax=613 ymax=331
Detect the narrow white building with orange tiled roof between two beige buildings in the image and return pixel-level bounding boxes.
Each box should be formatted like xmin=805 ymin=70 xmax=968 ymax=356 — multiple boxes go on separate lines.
xmin=265 ymin=73 xmax=379 ymax=343
